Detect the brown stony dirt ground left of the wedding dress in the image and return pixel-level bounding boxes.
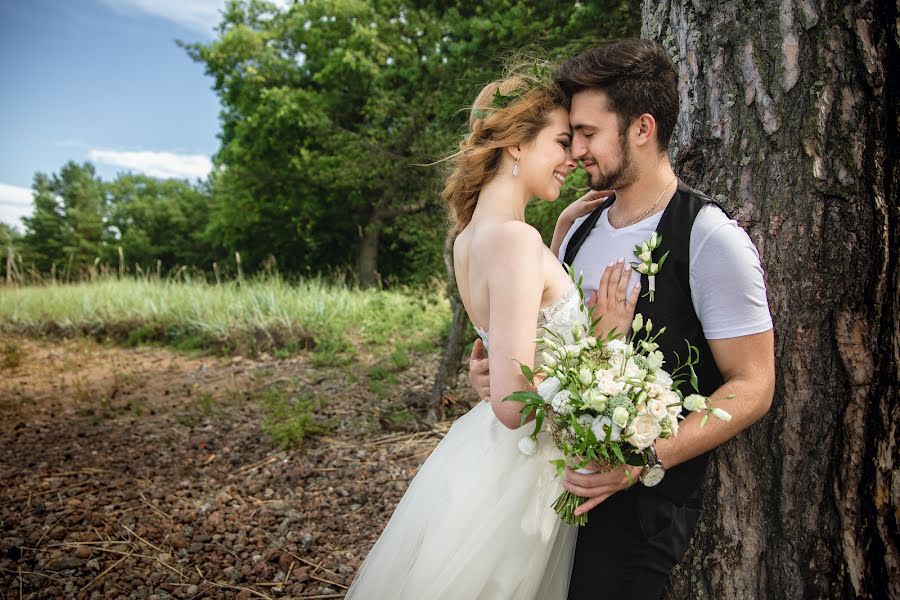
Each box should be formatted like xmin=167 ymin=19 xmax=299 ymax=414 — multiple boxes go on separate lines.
xmin=0 ymin=336 xmax=464 ymax=599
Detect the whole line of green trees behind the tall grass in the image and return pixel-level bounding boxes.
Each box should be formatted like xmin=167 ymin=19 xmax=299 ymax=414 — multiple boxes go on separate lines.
xmin=0 ymin=0 xmax=640 ymax=286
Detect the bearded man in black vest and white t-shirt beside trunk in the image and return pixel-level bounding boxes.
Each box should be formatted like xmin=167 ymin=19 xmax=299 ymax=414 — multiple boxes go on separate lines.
xmin=470 ymin=40 xmax=775 ymax=600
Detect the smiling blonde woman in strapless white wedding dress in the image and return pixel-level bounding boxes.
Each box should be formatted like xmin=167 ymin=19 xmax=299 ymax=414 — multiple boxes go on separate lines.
xmin=346 ymin=63 xmax=637 ymax=600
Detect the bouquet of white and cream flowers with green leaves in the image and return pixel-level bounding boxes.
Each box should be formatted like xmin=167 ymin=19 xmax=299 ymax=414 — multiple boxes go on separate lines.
xmin=504 ymin=274 xmax=731 ymax=525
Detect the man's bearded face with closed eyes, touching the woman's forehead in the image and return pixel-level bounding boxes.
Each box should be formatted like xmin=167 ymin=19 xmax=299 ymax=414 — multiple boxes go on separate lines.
xmin=569 ymin=90 xmax=638 ymax=190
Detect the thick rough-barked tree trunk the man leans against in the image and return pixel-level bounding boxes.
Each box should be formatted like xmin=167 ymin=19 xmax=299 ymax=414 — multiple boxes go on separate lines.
xmin=643 ymin=0 xmax=900 ymax=600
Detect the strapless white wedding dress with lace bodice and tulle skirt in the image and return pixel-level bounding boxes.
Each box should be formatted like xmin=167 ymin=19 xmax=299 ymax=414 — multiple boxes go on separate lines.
xmin=346 ymin=284 xmax=586 ymax=600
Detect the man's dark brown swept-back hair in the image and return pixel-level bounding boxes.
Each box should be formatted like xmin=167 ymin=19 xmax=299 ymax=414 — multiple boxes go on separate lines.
xmin=555 ymin=38 xmax=678 ymax=152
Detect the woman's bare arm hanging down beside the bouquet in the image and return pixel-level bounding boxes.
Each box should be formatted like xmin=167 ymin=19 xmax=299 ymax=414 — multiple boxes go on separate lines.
xmin=486 ymin=222 xmax=544 ymax=429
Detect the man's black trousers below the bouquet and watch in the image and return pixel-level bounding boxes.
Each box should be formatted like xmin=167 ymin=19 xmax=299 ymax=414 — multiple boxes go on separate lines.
xmin=569 ymin=483 xmax=700 ymax=600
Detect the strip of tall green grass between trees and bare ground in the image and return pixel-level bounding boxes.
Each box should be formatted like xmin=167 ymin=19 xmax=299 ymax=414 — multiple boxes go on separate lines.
xmin=0 ymin=276 xmax=449 ymax=355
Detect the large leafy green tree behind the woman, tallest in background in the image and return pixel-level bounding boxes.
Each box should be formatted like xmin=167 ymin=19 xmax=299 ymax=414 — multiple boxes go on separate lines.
xmin=184 ymin=0 xmax=638 ymax=285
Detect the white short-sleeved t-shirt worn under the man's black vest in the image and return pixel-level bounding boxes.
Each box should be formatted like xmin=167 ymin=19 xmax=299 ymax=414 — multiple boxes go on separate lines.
xmin=559 ymin=204 xmax=772 ymax=340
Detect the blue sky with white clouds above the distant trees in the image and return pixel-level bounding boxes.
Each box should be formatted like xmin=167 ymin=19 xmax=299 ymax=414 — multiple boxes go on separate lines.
xmin=0 ymin=0 xmax=244 ymax=230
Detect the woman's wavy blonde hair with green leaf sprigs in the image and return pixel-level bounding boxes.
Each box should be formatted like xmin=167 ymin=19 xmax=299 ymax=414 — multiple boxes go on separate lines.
xmin=441 ymin=62 xmax=568 ymax=231
